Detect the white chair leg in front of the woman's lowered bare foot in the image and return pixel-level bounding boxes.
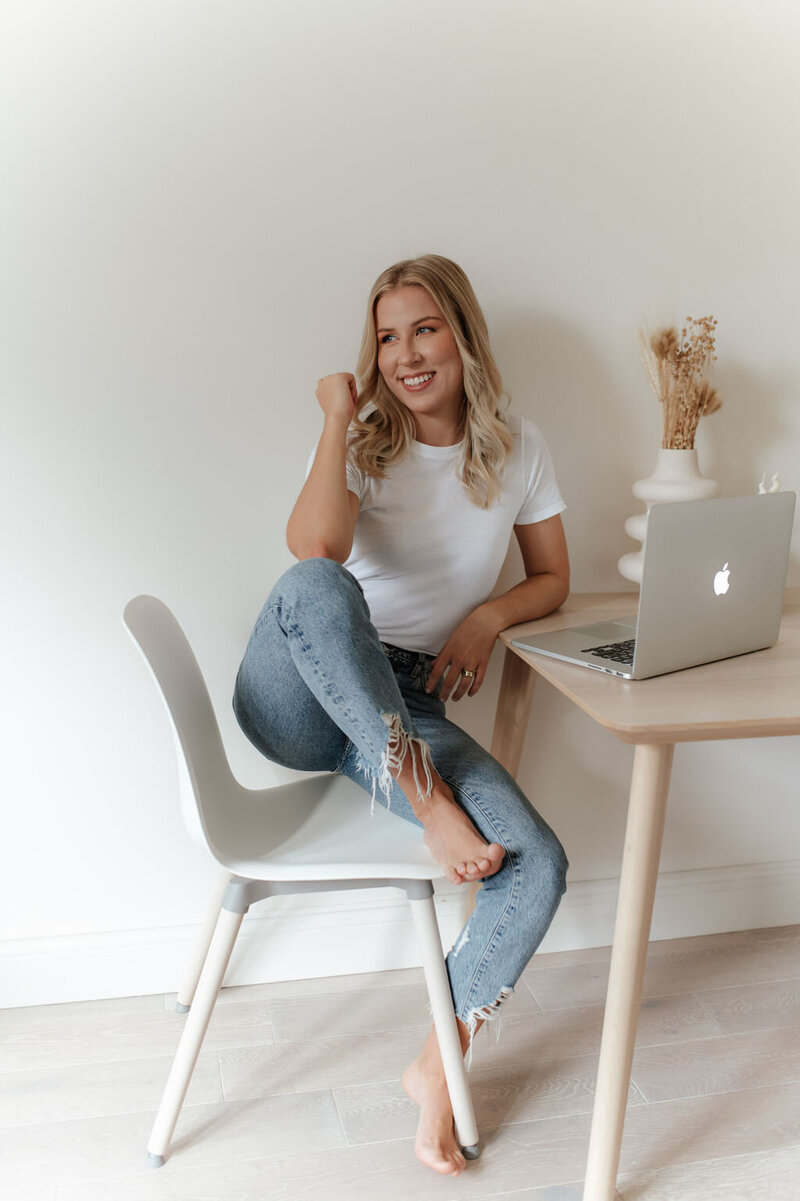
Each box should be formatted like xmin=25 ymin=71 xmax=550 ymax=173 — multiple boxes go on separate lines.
xmin=408 ymin=897 xmax=479 ymax=1159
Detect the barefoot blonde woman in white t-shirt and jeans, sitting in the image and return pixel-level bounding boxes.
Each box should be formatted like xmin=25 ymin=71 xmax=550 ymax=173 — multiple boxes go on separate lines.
xmin=234 ymin=255 xmax=569 ymax=1176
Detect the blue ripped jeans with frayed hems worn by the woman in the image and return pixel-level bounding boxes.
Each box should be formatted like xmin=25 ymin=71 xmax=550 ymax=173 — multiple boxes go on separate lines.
xmin=233 ymin=558 xmax=567 ymax=1034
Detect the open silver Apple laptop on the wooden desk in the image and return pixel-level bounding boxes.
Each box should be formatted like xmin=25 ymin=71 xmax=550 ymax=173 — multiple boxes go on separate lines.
xmin=512 ymin=492 xmax=795 ymax=680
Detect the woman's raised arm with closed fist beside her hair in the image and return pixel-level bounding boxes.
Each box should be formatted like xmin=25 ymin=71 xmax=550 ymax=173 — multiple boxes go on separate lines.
xmin=286 ymin=371 xmax=358 ymax=563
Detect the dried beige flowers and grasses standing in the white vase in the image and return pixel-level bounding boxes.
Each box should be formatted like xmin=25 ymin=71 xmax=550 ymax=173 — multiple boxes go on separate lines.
xmin=641 ymin=317 xmax=722 ymax=450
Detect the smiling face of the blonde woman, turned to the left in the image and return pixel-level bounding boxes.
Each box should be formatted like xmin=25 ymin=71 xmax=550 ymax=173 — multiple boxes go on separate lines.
xmin=375 ymin=283 xmax=464 ymax=441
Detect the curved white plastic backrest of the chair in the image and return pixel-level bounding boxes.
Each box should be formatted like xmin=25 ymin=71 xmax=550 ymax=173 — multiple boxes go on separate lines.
xmin=123 ymin=596 xmax=235 ymax=858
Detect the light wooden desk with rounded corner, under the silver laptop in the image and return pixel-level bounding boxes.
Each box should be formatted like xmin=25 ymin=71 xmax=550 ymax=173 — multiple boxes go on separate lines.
xmin=491 ymin=588 xmax=800 ymax=1201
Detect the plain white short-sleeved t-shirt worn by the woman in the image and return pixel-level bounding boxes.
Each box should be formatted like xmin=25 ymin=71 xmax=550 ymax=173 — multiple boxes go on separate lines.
xmin=305 ymin=416 xmax=566 ymax=655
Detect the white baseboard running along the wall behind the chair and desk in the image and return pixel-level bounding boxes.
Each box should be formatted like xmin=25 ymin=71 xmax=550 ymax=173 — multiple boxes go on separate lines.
xmin=0 ymin=860 xmax=800 ymax=1008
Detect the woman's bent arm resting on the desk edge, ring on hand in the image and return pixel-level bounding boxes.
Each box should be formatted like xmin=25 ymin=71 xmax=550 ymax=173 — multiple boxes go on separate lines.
xmin=428 ymin=515 xmax=569 ymax=700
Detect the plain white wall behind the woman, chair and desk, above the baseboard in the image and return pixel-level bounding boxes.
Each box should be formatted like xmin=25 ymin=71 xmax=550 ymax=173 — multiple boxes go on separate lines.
xmin=0 ymin=0 xmax=800 ymax=1004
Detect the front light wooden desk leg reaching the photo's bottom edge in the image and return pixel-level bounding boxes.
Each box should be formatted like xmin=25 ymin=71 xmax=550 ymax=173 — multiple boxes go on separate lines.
xmin=584 ymin=743 xmax=674 ymax=1201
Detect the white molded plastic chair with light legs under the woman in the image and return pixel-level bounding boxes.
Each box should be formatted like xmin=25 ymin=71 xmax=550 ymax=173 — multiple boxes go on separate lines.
xmin=124 ymin=596 xmax=479 ymax=1167
